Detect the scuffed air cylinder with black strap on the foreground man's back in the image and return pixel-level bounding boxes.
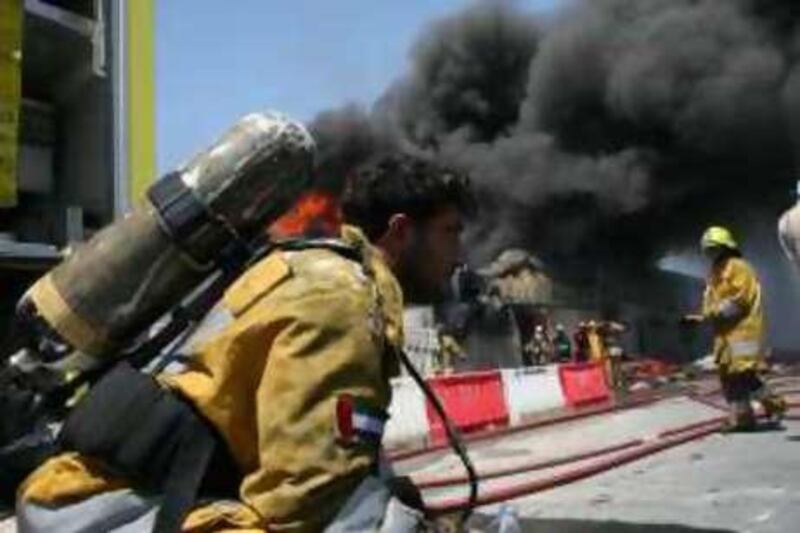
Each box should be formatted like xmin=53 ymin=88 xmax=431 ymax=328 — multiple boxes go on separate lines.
xmin=17 ymin=113 xmax=315 ymax=362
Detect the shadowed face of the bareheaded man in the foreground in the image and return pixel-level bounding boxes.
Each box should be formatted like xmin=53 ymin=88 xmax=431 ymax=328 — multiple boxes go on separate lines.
xmin=401 ymin=207 xmax=464 ymax=303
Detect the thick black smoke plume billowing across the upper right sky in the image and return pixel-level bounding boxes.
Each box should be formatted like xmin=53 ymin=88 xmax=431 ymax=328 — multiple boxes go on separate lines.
xmin=313 ymin=0 xmax=800 ymax=268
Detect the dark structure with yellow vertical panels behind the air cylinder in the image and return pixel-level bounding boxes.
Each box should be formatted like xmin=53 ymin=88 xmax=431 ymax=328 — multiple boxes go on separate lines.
xmin=0 ymin=0 xmax=155 ymax=335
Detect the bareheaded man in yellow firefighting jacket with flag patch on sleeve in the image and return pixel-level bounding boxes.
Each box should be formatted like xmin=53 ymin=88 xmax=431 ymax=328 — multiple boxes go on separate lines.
xmin=17 ymin=156 xmax=472 ymax=532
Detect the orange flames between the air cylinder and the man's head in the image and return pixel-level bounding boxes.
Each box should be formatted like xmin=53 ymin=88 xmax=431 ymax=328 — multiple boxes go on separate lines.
xmin=269 ymin=191 xmax=342 ymax=238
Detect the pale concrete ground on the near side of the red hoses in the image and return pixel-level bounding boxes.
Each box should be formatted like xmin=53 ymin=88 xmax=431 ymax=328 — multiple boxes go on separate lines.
xmin=472 ymin=422 xmax=800 ymax=533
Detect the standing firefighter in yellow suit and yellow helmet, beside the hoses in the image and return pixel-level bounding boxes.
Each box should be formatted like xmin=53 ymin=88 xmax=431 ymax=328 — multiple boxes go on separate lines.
xmin=685 ymin=226 xmax=786 ymax=431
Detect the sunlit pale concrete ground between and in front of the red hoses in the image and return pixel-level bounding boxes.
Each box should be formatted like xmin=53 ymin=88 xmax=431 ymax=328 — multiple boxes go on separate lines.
xmin=410 ymin=388 xmax=800 ymax=533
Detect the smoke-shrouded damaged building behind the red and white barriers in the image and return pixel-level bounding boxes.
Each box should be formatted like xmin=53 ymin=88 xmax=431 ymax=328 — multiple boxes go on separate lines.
xmin=406 ymin=243 xmax=707 ymax=373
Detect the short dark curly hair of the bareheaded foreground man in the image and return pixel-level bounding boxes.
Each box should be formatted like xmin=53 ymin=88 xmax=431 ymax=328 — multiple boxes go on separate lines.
xmin=342 ymin=154 xmax=476 ymax=240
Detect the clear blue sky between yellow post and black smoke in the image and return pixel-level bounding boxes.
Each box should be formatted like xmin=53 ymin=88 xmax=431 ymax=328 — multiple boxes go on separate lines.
xmin=156 ymin=0 xmax=562 ymax=174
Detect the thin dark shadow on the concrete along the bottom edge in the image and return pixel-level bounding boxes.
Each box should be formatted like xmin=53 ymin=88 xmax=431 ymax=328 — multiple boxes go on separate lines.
xmin=471 ymin=514 xmax=734 ymax=533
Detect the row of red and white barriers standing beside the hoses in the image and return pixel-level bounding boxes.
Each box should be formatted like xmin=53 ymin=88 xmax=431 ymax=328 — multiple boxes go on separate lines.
xmin=383 ymin=363 xmax=611 ymax=449
